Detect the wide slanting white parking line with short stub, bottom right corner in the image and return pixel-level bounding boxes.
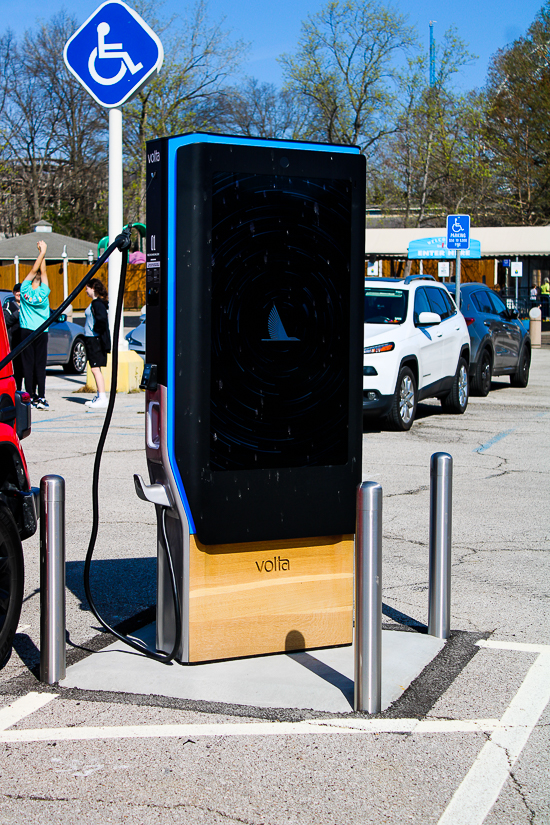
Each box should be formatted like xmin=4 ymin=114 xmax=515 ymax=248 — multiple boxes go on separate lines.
xmin=438 ymin=642 xmax=550 ymax=825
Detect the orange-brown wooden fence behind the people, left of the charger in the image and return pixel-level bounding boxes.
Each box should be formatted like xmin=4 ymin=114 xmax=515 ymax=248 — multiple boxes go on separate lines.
xmin=0 ymin=262 xmax=145 ymax=310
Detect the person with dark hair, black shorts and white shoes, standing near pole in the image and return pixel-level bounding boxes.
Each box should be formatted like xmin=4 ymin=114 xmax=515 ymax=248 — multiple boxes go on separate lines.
xmin=84 ymin=278 xmax=111 ymax=411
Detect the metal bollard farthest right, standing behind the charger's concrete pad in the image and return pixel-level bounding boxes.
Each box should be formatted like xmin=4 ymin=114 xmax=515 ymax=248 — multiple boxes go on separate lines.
xmin=428 ymin=453 xmax=453 ymax=639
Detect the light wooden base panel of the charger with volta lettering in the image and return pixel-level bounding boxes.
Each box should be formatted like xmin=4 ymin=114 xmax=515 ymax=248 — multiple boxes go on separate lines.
xmin=189 ymin=536 xmax=353 ymax=662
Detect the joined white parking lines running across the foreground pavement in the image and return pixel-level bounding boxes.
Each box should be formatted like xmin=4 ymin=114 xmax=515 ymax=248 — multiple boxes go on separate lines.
xmin=0 ymin=640 xmax=550 ymax=825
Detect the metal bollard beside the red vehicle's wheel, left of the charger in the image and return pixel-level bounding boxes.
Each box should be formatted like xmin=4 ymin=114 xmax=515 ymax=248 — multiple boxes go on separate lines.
xmin=40 ymin=475 xmax=66 ymax=685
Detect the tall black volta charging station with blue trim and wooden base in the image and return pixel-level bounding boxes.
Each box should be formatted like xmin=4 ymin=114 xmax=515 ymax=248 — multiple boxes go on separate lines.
xmin=142 ymin=133 xmax=365 ymax=663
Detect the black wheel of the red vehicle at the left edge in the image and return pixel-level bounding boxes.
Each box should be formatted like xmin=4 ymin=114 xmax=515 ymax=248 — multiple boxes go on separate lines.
xmin=0 ymin=505 xmax=25 ymax=668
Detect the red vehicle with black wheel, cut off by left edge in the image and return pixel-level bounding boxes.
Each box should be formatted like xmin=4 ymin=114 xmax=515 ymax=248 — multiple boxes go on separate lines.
xmin=0 ymin=311 xmax=38 ymax=668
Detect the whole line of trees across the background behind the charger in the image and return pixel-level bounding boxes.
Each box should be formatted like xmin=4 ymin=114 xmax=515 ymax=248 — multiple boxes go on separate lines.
xmin=0 ymin=0 xmax=550 ymax=232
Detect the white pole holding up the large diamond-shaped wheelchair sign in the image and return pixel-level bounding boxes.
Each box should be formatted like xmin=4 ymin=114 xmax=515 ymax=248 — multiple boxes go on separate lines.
xmin=109 ymin=107 xmax=123 ymax=351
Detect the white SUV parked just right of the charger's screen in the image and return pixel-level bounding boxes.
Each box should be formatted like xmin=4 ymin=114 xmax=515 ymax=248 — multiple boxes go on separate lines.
xmin=363 ymin=275 xmax=470 ymax=430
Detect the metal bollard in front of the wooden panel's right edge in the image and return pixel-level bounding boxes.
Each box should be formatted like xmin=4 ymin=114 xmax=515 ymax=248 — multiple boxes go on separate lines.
xmin=353 ymin=481 xmax=382 ymax=713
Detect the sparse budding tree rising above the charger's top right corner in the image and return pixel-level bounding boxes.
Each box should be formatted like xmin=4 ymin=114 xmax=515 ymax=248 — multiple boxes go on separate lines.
xmin=281 ymin=0 xmax=414 ymax=155
